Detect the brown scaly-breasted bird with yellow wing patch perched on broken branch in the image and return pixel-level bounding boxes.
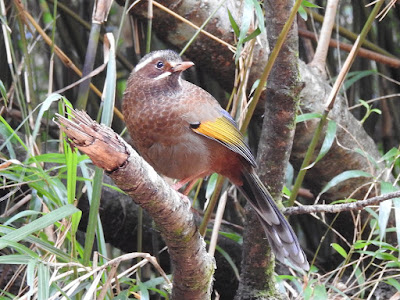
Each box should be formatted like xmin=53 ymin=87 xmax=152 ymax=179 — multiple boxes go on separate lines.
xmin=122 ymin=50 xmax=309 ymax=270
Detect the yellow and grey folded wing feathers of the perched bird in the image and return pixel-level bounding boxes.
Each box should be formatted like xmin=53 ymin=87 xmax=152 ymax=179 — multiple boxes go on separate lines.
xmin=191 ymin=109 xmax=256 ymax=167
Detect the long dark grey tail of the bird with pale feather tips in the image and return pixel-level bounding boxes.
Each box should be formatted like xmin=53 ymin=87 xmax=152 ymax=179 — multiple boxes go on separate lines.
xmin=239 ymin=170 xmax=310 ymax=270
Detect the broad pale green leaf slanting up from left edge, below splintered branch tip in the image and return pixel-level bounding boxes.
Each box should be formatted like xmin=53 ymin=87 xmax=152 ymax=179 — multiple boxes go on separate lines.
xmin=0 ymin=204 xmax=78 ymax=250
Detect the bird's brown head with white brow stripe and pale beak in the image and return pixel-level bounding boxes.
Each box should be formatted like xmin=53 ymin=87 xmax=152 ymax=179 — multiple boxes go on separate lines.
xmin=134 ymin=50 xmax=194 ymax=85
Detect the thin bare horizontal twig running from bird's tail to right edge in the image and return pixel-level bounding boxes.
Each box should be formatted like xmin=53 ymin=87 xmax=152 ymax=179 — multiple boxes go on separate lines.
xmin=283 ymin=191 xmax=400 ymax=215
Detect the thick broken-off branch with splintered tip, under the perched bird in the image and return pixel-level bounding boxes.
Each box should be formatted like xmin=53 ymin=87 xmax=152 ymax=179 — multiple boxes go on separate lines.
xmin=58 ymin=111 xmax=215 ymax=299
